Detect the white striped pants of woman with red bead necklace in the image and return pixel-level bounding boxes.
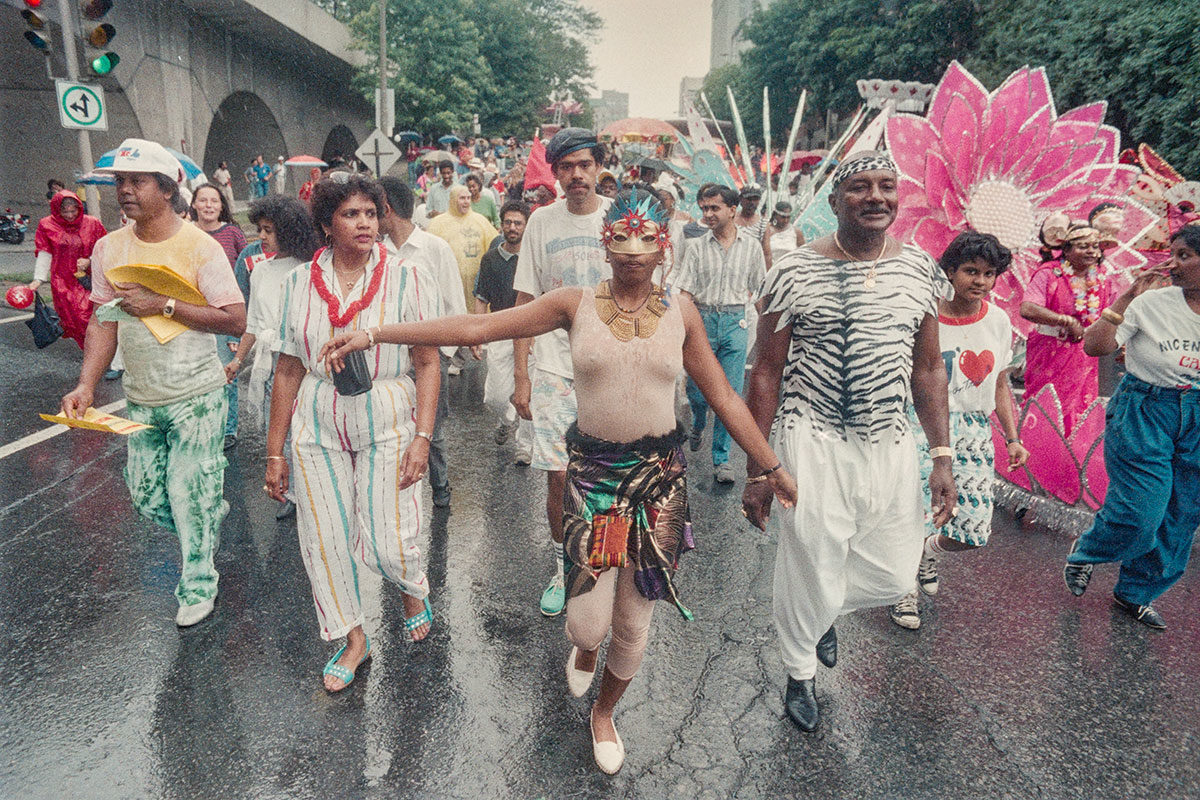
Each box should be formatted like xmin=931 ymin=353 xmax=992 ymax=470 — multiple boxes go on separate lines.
xmin=290 ymin=374 xmax=430 ymax=640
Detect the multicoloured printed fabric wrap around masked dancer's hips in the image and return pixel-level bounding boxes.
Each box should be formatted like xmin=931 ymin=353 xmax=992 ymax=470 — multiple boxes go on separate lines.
xmin=563 ymin=425 xmax=696 ymax=620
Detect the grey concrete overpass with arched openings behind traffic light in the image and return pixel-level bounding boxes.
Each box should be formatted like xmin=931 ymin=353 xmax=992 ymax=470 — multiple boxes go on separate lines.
xmin=0 ymin=0 xmax=373 ymax=223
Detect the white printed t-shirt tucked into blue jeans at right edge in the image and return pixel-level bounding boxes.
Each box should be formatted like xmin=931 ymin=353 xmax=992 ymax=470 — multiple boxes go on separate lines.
xmin=1117 ymin=287 xmax=1200 ymax=389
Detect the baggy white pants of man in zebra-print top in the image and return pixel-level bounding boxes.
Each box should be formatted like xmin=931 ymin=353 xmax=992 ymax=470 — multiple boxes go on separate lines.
xmin=770 ymin=420 xmax=924 ymax=680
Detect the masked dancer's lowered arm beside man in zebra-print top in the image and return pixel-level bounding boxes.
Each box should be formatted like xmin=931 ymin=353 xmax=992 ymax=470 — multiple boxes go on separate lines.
xmin=676 ymin=296 xmax=796 ymax=507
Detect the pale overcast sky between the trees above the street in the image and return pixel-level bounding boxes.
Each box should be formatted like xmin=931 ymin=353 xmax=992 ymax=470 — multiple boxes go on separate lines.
xmin=581 ymin=0 xmax=713 ymax=119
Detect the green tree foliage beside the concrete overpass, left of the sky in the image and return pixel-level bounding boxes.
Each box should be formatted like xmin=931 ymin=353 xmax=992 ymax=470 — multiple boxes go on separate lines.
xmin=340 ymin=0 xmax=600 ymax=136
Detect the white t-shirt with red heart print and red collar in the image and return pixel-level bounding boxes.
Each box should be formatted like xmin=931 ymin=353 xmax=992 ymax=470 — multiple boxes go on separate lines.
xmin=937 ymin=301 xmax=1013 ymax=414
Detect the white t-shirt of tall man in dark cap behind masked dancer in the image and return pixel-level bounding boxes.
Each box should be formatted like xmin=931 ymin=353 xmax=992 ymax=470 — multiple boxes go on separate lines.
xmin=512 ymin=197 xmax=612 ymax=378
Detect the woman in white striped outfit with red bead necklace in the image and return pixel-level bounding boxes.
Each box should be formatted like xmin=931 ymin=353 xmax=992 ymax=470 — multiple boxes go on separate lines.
xmin=263 ymin=173 xmax=438 ymax=692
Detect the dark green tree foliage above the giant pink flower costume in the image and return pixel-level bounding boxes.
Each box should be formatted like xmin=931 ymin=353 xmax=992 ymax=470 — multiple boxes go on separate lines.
xmin=704 ymin=0 xmax=1200 ymax=176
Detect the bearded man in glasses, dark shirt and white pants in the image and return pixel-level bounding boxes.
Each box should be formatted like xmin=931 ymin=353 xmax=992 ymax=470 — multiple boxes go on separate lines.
xmin=475 ymin=201 xmax=533 ymax=467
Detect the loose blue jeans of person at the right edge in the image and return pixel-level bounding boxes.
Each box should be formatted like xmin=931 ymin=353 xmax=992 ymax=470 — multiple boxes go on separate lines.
xmin=1067 ymin=374 xmax=1200 ymax=606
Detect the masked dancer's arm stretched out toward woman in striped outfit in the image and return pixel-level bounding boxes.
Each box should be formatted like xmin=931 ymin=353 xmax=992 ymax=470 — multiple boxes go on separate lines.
xmin=317 ymin=288 xmax=582 ymax=372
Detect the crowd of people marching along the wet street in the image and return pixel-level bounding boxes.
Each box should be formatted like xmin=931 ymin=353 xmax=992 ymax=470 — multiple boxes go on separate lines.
xmin=35 ymin=118 xmax=1200 ymax=774
